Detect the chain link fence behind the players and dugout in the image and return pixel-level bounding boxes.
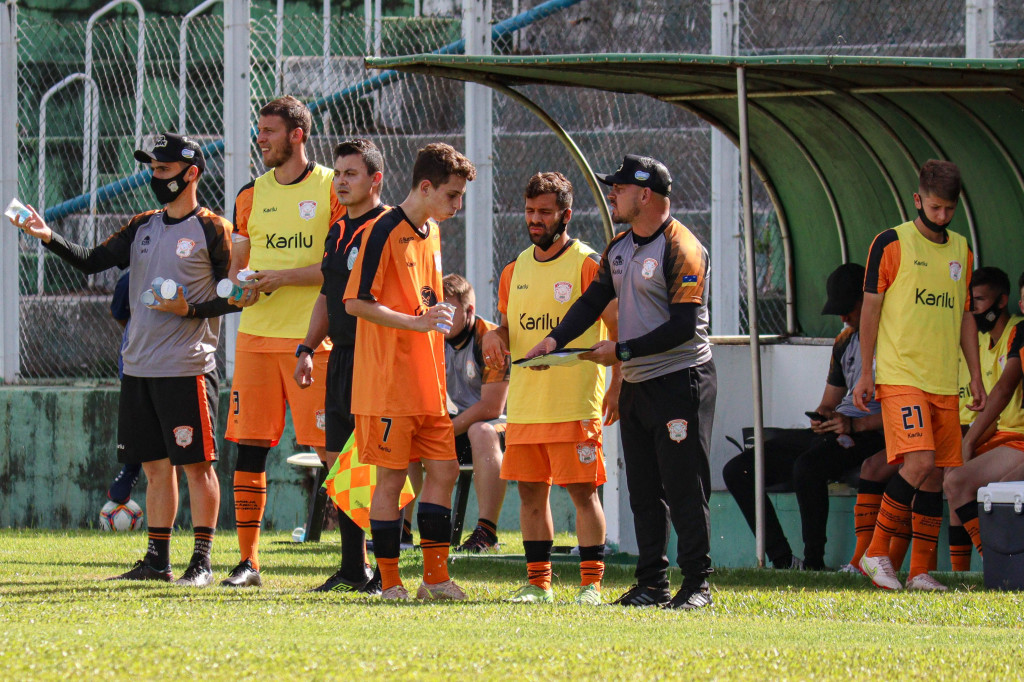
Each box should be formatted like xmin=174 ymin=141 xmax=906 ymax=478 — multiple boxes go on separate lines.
xmin=9 ymin=0 xmax=1024 ymax=382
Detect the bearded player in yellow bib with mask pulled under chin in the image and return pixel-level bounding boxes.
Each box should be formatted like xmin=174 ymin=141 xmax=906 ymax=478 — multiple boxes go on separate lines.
xmin=483 ymin=172 xmax=618 ymax=604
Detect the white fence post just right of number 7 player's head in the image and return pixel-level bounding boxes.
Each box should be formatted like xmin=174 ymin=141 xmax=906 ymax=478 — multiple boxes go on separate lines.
xmin=462 ymin=0 xmax=495 ymax=319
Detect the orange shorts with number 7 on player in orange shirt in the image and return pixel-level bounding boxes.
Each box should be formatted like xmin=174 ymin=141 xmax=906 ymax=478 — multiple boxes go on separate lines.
xmin=355 ymin=415 xmax=456 ymax=469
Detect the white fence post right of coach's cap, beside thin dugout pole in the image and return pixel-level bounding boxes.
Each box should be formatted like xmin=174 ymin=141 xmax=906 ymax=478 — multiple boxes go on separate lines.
xmin=711 ymin=0 xmax=742 ymax=336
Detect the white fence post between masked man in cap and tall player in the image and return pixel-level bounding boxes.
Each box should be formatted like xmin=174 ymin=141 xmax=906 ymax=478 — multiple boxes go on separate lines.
xmin=224 ymin=0 xmax=252 ymax=378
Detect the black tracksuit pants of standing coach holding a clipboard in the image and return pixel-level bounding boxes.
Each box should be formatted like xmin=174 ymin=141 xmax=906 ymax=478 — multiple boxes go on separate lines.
xmin=618 ymin=360 xmax=718 ymax=589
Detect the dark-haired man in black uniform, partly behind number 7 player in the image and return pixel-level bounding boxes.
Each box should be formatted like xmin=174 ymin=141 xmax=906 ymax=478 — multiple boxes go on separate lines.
xmin=295 ymin=138 xmax=389 ymax=594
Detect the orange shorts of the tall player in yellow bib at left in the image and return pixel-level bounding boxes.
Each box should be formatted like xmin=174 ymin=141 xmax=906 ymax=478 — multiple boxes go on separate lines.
xmin=224 ymin=346 xmax=329 ymax=447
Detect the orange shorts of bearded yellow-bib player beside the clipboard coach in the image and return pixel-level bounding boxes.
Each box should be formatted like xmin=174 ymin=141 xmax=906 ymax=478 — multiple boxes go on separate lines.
xmin=502 ymin=419 xmax=607 ymax=485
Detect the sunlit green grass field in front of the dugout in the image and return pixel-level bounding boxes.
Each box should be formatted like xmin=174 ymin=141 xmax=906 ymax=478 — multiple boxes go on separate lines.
xmin=0 ymin=530 xmax=1024 ymax=680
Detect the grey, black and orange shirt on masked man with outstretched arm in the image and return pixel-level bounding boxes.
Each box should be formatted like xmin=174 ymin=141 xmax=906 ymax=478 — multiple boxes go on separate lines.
xmin=46 ymin=207 xmax=238 ymax=377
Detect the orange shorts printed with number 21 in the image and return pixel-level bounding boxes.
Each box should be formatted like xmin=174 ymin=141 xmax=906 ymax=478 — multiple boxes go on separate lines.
xmin=877 ymin=385 xmax=964 ymax=467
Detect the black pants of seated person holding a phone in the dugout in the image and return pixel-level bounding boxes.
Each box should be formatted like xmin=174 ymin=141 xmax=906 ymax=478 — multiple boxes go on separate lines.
xmin=722 ymin=429 xmax=886 ymax=568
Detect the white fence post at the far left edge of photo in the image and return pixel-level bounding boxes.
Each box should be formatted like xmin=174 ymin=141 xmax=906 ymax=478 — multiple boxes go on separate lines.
xmin=0 ymin=0 xmax=24 ymax=383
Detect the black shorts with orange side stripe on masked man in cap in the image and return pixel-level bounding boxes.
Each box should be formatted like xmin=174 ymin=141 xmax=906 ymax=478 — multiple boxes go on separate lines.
xmin=118 ymin=372 xmax=217 ymax=465
